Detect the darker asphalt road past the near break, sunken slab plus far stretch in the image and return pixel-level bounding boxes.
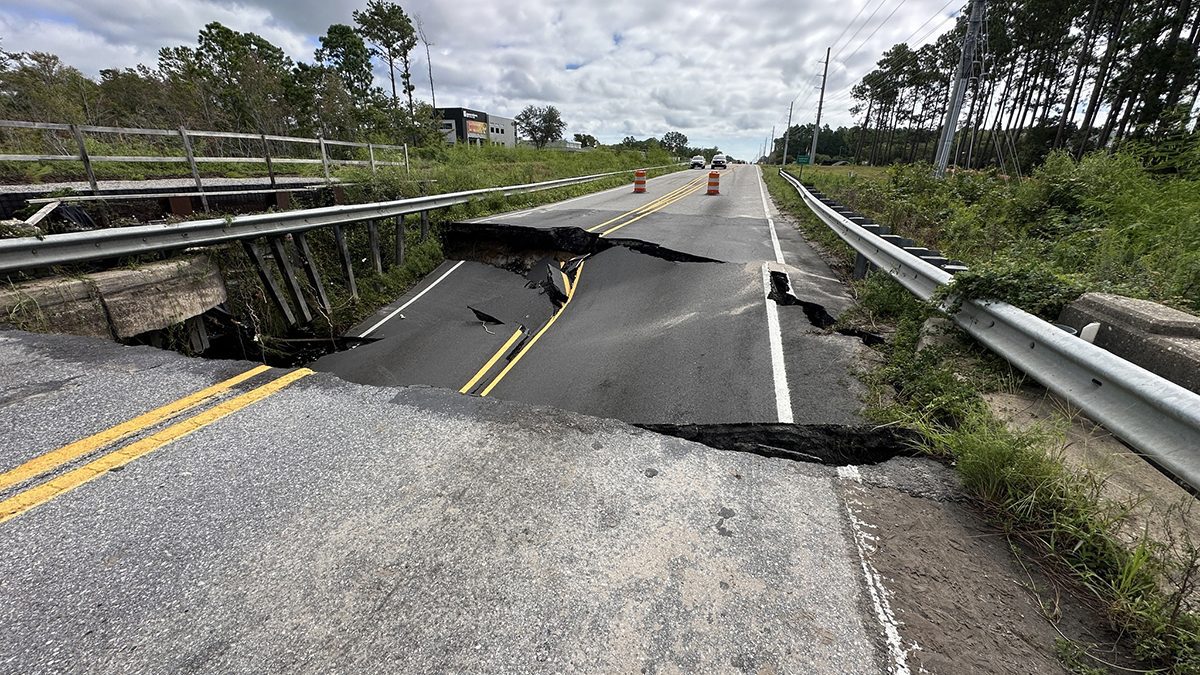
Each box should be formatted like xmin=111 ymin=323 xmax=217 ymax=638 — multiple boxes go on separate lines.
xmin=312 ymin=165 xmax=863 ymax=424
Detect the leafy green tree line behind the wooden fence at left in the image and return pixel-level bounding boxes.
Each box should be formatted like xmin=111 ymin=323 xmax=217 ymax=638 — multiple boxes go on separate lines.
xmin=0 ymin=0 xmax=440 ymax=144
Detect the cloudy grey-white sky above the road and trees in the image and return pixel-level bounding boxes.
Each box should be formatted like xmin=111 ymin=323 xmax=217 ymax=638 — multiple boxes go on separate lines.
xmin=0 ymin=0 xmax=965 ymax=159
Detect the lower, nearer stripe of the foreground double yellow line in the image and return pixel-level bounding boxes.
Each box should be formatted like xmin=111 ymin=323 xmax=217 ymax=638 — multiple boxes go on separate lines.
xmin=0 ymin=368 xmax=313 ymax=522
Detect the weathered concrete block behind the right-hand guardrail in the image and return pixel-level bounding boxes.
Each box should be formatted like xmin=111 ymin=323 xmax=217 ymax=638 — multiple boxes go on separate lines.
xmin=1058 ymin=293 xmax=1200 ymax=394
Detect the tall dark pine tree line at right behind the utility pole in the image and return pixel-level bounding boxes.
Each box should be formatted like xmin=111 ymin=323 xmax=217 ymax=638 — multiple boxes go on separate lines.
xmin=768 ymin=0 xmax=1200 ymax=173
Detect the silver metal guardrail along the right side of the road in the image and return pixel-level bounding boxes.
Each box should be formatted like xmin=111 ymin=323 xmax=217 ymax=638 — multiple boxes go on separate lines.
xmin=779 ymin=169 xmax=1200 ymax=489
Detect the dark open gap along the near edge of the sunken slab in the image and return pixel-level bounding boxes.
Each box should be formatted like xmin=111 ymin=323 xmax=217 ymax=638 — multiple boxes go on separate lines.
xmin=636 ymin=423 xmax=917 ymax=465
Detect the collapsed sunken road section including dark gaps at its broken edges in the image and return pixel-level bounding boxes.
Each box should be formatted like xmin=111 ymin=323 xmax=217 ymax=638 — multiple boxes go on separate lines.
xmin=311 ymin=223 xmax=908 ymax=464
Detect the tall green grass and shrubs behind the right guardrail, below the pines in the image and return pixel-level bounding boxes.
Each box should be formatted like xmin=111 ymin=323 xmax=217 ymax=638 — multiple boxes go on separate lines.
xmin=805 ymin=153 xmax=1200 ymax=311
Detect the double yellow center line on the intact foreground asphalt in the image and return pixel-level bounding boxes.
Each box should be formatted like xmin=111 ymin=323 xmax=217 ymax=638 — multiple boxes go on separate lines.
xmin=0 ymin=365 xmax=313 ymax=522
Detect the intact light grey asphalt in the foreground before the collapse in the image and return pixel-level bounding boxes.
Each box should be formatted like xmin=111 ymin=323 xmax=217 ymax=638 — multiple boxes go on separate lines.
xmin=0 ymin=331 xmax=889 ymax=674
